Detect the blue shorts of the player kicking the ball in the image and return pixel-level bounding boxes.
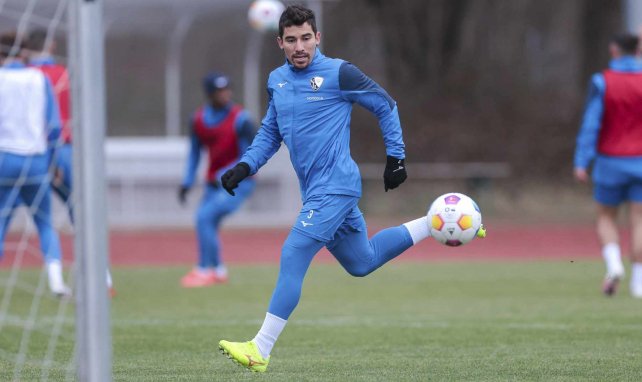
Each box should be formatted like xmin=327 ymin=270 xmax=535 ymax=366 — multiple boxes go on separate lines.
xmin=292 ymin=195 xmax=366 ymax=244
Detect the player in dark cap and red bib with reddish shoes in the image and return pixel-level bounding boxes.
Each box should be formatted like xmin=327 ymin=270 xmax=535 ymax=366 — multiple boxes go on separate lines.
xmin=178 ymin=73 xmax=256 ymax=288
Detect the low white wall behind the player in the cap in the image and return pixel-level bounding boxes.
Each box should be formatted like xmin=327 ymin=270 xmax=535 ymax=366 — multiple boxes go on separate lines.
xmin=105 ymin=138 xmax=301 ymax=227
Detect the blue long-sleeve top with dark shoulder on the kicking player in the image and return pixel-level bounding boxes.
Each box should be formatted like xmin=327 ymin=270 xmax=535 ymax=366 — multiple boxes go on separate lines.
xmin=241 ymin=49 xmax=405 ymax=201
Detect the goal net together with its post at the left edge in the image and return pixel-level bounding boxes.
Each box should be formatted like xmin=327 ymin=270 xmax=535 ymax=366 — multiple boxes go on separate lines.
xmin=0 ymin=0 xmax=111 ymax=381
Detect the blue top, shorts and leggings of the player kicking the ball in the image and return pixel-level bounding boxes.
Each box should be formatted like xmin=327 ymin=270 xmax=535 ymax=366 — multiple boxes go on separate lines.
xmin=241 ymin=49 xmax=412 ymax=319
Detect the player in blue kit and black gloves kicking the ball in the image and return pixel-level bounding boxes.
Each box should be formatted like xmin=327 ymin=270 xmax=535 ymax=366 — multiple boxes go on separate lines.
xmin=219 ymin=5 xmax=456 ymax=372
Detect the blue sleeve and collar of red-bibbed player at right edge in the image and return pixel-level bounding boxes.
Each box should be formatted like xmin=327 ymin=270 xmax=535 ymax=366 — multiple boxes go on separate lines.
xmin=574 ymin=56 xmax=642 ymax=169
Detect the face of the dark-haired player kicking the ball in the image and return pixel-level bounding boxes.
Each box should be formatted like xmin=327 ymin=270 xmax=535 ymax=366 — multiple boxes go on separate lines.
xmin=276 ymin=22 xmax=321 ymax=69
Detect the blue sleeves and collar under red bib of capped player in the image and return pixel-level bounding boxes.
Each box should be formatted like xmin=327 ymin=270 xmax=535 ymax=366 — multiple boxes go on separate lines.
xmin=182 ymin=105 xmax=256 ymax=188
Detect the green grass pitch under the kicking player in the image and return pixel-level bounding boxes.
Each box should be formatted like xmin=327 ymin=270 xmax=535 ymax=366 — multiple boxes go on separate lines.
xmin=0 ymin=261 xmax=642 ymax=382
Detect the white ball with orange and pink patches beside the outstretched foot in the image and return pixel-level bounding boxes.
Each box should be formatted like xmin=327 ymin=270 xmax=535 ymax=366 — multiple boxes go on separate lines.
xmin=428 ymin=192 xmax=483 ymax=247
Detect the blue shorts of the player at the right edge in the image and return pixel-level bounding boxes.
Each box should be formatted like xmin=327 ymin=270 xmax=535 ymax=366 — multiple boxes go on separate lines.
xmin=592 ymin=156 xmax=642 ymax=206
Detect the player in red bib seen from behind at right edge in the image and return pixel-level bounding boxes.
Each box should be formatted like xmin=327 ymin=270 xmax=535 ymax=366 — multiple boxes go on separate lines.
xmin=575 ymin=34 xmax=642 ymax=298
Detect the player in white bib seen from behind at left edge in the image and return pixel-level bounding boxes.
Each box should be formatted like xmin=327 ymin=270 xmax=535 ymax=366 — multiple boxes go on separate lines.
xmin=0 ymin=33 xmax=71 ymax=296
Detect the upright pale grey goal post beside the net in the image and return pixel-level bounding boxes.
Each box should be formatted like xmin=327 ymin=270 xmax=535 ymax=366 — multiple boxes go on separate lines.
xmin=68 ymin=0 xmax=112 ymax=382
